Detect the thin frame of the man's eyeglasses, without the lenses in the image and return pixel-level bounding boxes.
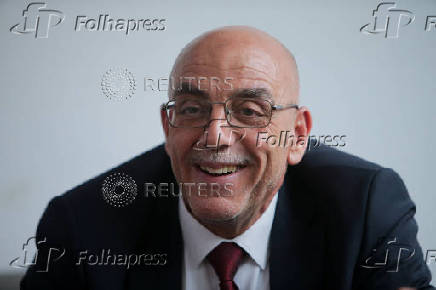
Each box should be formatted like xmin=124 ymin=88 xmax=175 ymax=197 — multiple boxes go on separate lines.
xmin=161 ymin=96 xmax=300 ymax=128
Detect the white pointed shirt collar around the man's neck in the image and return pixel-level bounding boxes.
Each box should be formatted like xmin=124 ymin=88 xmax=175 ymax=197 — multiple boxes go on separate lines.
xmin=179 ymin=193 xmax=278 ymax=270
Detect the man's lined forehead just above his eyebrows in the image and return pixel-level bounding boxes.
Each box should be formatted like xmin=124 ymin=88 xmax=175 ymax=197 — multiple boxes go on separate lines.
xmin=172 ymin=45 xmax=280 ymax=98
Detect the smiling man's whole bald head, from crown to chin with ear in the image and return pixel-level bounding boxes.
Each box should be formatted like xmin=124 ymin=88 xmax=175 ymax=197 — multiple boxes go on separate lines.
xmin=162 ymin=28 xmax=311 ymax=238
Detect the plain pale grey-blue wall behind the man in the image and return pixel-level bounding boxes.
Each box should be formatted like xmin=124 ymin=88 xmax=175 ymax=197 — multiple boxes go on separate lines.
xmin=0 ymin=0 xmax=436 ymax=286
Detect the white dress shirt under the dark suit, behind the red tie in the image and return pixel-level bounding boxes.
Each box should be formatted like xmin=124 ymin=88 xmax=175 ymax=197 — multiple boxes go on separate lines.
xmin=179 ymin=193 xmax=278 ymax=290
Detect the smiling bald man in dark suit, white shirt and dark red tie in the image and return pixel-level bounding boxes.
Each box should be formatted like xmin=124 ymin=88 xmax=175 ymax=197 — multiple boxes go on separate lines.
xmin=21 ymin=27 xmax=434 ymax=290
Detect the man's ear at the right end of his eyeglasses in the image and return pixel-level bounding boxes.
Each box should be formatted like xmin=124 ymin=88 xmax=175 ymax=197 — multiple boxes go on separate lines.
xmin=288 ymin=107 xmax=312 ymax=165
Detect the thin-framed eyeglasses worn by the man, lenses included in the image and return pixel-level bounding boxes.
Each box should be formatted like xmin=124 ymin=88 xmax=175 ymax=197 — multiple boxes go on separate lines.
xmin=161 ymin=96 xmax=299 ymax=128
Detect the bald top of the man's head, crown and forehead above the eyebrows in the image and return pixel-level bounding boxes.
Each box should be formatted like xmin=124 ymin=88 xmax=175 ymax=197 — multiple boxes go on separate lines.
xmin=169 ymin=26 xmax=299 ymax=103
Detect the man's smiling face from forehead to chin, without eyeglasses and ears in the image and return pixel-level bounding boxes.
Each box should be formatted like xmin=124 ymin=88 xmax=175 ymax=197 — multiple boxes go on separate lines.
xmin=162 ymin=32 xmax=310 ymax=234
